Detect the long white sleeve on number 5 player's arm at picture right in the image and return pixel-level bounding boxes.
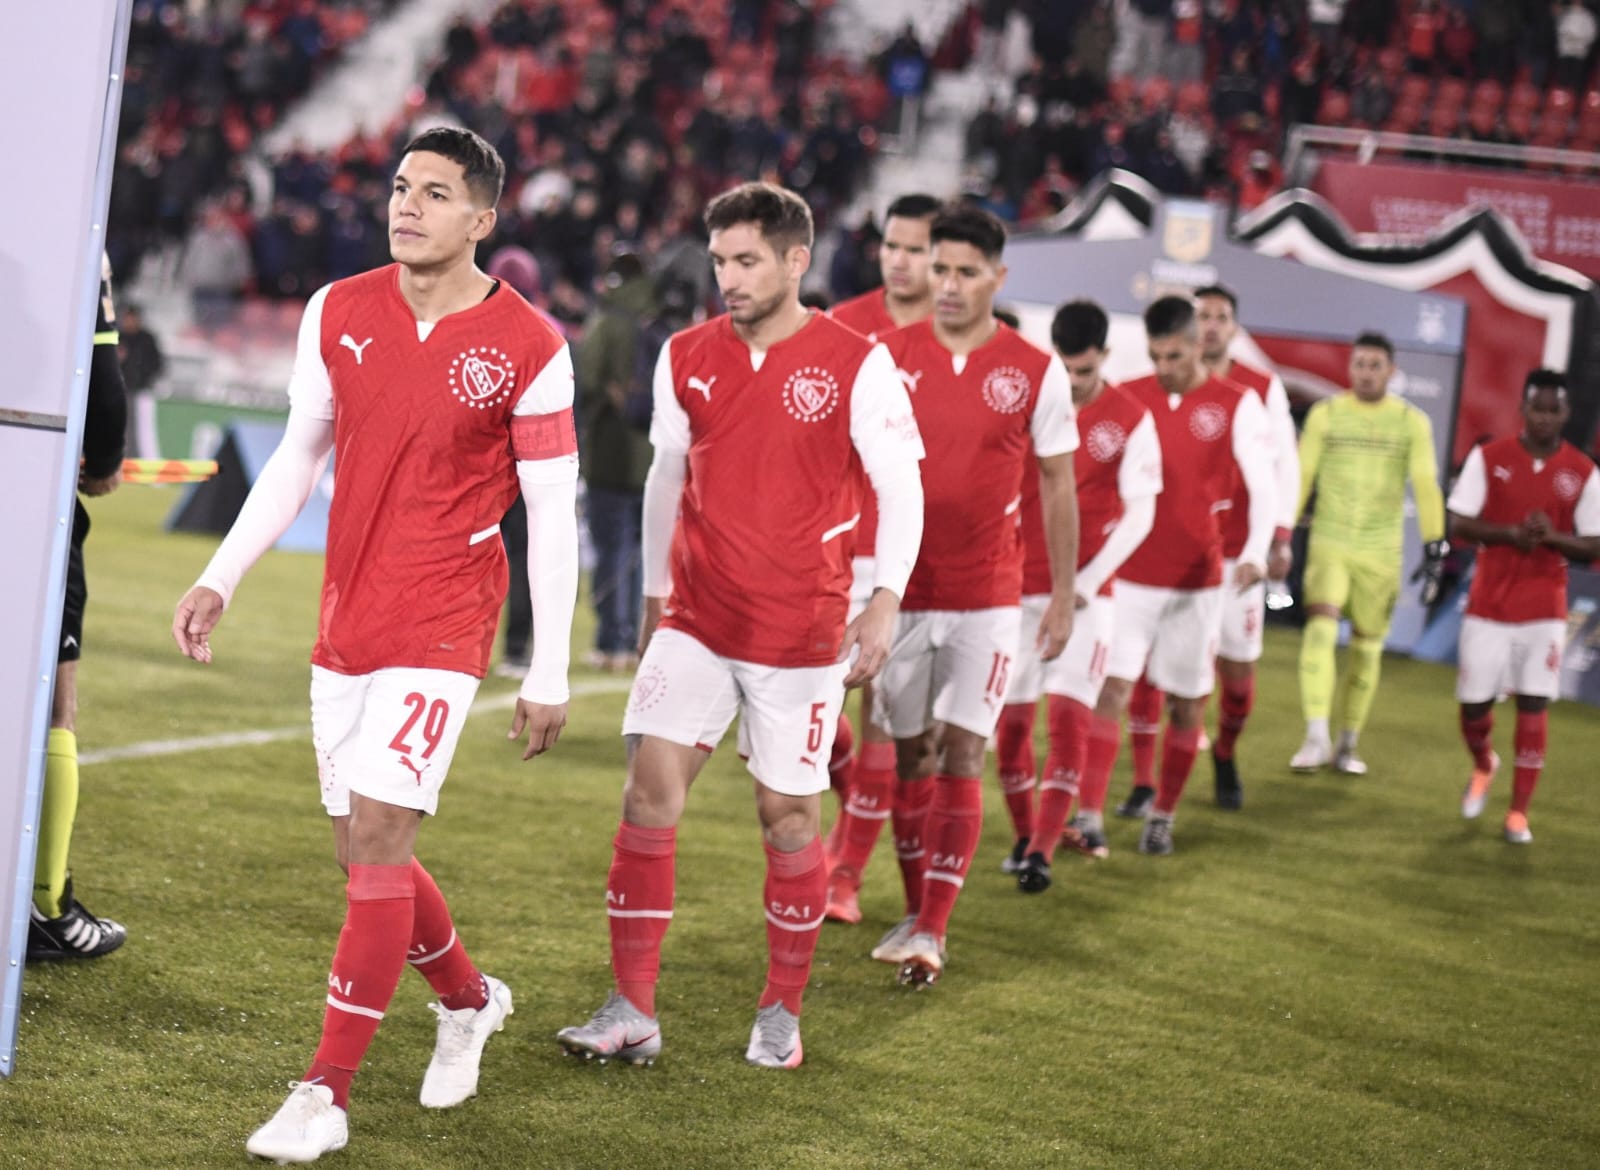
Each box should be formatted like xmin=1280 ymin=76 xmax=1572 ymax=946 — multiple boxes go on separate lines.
xmin=850 ymin=346 xmax=923 ymax=597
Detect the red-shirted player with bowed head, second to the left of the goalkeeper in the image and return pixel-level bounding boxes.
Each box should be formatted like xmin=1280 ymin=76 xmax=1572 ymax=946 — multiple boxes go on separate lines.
xmin=1082 ymin=296 xmax=1277 ymax=855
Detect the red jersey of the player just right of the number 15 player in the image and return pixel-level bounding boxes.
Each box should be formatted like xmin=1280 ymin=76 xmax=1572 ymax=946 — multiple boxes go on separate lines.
xmin=1021 ymin=386 xmax=1162 ymax=597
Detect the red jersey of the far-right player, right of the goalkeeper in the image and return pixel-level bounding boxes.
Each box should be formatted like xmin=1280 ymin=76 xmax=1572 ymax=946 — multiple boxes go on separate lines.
xmin=1448 ymin=439 xmax=1600 ymax=623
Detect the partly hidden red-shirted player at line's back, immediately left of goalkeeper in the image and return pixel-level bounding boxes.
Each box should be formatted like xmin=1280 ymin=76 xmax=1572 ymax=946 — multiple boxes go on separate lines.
xmin=1128 ymin=285 xmax=1299 ymax=808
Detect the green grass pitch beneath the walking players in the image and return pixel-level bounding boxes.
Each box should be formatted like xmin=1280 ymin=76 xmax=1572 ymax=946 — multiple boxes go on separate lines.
xmin=0 ymin=488 xmax=1600 ymax=1170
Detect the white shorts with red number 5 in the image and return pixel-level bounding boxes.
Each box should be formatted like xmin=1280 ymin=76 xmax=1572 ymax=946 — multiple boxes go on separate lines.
xmin=622 ymin=629 xmax=850 ymax=795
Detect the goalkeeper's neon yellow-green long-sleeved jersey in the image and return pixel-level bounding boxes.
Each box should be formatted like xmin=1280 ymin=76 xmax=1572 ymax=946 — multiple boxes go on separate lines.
xmin=1296 ymin=392 xmax=1445 ymax=557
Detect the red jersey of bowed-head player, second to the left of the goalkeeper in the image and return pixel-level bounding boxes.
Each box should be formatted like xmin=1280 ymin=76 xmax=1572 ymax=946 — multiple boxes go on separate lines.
xmin=1118 ymin=375 xmax=1270 ymax=589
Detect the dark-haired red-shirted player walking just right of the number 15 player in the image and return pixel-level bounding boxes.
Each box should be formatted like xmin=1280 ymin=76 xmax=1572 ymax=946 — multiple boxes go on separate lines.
xmin=997 ymin=301 xmax=1162 ymax=893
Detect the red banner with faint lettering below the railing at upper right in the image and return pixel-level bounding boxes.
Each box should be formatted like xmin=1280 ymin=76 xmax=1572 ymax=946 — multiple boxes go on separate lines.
xmin=1312 ymin=158 xmax=1600 ymax=278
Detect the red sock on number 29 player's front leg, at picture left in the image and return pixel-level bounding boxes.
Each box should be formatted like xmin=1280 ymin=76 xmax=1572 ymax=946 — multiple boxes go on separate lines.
xmin=302 ymin=864 xmax=416 ymax=1109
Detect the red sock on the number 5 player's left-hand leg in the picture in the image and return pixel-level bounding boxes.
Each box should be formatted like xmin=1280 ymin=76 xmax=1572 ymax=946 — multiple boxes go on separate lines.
xmin=605 ymin=821 xmax=678 ymax=1016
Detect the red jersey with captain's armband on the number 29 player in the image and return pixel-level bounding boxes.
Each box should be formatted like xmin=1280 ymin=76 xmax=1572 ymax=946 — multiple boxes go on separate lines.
xmin=298 ymin=264 xmax=578 ymax=679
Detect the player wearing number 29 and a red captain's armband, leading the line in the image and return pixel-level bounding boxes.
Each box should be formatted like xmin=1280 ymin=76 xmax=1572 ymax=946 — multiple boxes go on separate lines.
xmin=173 ymin=130 xmax=578 ymax=1162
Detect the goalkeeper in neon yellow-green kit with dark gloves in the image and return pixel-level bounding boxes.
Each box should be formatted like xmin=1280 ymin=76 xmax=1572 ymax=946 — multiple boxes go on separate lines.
xmin=1290 ymin=333 xmax=1448 ymax=776
